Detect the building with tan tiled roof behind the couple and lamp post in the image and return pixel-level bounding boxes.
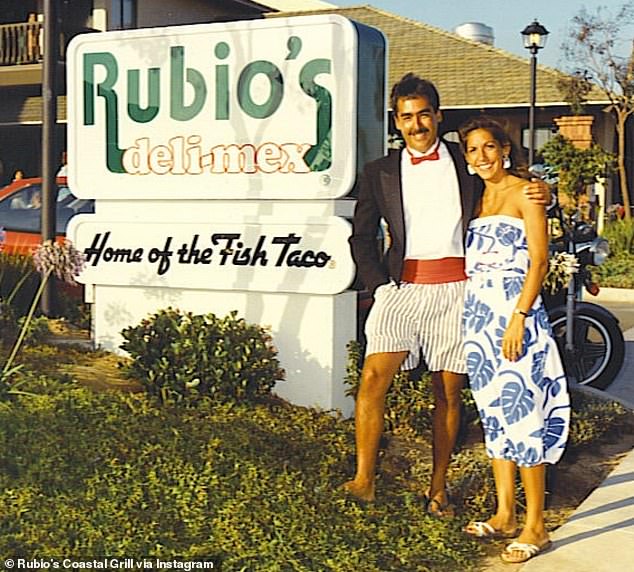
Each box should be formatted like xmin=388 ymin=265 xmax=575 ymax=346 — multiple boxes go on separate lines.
xmin=266 ymin=6 xmax=634 ymax=208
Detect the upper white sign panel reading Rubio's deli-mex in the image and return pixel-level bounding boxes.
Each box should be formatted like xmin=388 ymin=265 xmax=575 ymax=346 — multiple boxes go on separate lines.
xmin=67 ymin=15 xmax=358 ymax=200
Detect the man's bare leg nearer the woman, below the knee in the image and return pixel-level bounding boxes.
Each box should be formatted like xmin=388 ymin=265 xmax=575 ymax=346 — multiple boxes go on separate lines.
xmin=427 ymin=371 xmax=465 ymax=516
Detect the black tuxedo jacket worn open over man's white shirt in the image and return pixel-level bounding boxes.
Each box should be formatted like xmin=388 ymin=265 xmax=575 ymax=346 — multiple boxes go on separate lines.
xmin=350 ymin=136 xmax=483 ymax=292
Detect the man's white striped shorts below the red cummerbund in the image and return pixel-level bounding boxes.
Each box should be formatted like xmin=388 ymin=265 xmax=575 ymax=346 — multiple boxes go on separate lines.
xmin=365 ymin=280 xmax=467 ymax=373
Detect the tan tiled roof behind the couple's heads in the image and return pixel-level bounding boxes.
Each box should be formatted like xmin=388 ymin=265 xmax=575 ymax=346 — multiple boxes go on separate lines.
xmin=266 ymin=6 xmax=605 ymax=109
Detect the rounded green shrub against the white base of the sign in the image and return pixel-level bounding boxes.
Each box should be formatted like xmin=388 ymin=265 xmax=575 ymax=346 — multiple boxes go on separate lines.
xmin=121 ymin=308 xmax=284 ymax=404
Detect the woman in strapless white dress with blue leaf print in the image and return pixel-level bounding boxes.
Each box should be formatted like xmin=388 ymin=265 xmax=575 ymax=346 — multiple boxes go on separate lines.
xmin=460 ymin=116 xmax=570 ymax=563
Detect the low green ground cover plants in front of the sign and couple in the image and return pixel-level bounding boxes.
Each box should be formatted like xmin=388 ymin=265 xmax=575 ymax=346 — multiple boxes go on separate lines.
xmin=0 ymin=336 xmax=632 ymax=572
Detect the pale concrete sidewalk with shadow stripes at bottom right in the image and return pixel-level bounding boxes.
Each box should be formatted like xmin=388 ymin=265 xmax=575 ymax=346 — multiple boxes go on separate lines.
xmin=517 ymin=322 xmax=634 ymax=572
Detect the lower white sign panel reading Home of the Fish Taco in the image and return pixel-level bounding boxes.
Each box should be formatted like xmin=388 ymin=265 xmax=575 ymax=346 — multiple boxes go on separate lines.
xmin=68 ymin=215 xmax=355 ymax=294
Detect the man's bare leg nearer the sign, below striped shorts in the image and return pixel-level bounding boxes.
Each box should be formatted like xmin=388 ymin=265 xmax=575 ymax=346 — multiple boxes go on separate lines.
xmin=343 ymin=351 xmax=407 ymax=501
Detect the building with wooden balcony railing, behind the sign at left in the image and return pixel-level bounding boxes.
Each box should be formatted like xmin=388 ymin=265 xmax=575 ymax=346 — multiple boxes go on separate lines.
xmin=0 ymin=0 xmax=288 ymax=182
